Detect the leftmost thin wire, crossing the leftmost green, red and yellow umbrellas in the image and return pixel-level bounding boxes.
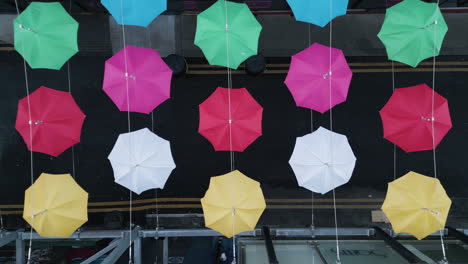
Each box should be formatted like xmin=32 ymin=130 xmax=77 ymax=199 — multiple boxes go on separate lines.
xmin=15 ymin=0 xmax=34 ymax=264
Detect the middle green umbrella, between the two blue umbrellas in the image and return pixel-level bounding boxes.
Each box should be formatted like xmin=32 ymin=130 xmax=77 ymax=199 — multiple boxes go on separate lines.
xmin=195 ymin=0 xmax=262 ymax=69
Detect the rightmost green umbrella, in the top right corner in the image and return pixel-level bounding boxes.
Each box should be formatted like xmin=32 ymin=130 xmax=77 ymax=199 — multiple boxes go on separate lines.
xmin=378 ymin=0 xmax=448 ymax=67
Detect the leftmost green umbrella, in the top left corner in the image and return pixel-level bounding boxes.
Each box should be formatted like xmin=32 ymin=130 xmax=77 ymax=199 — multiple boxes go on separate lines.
xmin=13 ymin=2 xmax=78 ymax=70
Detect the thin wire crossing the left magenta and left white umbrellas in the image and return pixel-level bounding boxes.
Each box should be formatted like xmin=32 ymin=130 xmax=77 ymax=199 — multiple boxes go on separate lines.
xmin=120 ymin=0 xmax=133 ymax=264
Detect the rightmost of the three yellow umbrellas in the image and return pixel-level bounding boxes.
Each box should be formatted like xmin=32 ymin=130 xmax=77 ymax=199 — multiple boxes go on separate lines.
xmin=382 ymin=171 xmax=452 ymax=240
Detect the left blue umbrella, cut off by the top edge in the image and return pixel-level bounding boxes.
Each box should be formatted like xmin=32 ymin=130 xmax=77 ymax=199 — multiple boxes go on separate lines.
xmin=101 ymin=0 xmax=167 ymax=27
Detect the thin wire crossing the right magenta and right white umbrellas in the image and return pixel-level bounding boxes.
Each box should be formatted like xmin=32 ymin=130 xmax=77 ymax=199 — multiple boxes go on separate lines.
xmin=328 ymin=0 xmax=341 ymax=264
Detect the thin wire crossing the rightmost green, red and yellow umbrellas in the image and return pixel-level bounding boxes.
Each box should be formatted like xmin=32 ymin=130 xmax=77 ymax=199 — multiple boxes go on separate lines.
xmin=431 ymin=0 xmax=448 ymax=263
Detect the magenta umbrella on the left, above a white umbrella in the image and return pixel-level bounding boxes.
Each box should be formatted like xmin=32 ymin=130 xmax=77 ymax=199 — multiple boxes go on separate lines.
xmin=103 ymin=46 xmax=172 ymax=114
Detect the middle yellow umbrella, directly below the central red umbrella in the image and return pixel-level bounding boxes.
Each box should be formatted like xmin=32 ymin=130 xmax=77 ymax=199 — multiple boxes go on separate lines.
xmin=201 ymin=170 xmax=266 ymax=238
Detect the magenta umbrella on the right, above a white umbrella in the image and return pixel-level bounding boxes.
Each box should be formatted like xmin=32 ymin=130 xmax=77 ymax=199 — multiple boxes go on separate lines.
xmin=284 ymin=43 xmax=353 ymax=113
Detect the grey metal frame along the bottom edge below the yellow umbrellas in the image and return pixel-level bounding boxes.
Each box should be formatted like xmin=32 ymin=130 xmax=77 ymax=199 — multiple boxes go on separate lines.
xmin=0 ymin=227 xmax=468 ymax=264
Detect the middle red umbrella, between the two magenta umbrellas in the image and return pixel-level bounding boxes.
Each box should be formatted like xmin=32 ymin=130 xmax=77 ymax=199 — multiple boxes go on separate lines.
xmin=198 ymin=87 xmax=263 ymax=151
